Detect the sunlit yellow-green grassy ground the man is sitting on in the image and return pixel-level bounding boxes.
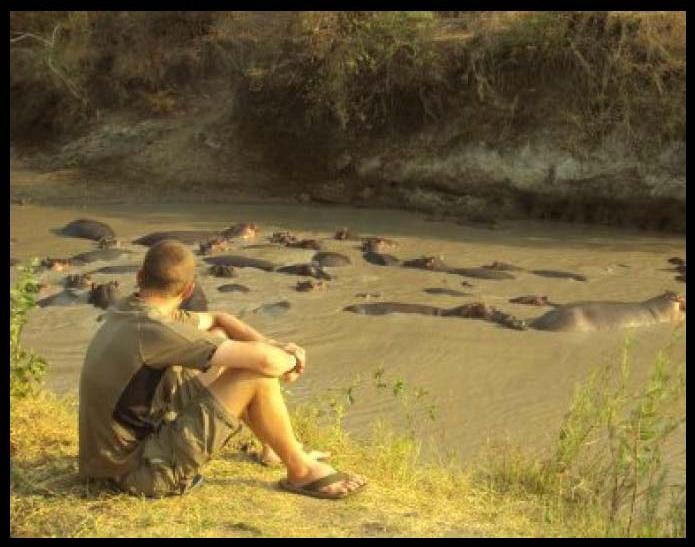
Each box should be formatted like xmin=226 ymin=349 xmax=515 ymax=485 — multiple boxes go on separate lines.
xmin=10 ymin=392 xmax=567 ymax=537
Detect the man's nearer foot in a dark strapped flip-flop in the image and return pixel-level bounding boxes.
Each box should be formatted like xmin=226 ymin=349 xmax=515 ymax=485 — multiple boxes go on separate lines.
xmin=279 ymin=461 xmax=367 ymax=499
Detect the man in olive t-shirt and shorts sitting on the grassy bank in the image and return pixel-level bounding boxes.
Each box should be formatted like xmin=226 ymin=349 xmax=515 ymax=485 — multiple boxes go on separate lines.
xmin=79 ymin=240 xmax=366 ymax=498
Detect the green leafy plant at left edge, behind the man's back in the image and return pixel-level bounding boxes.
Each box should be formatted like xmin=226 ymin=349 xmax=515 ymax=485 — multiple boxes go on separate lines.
xmin=10 ymin=260 xmax=46 ymax=397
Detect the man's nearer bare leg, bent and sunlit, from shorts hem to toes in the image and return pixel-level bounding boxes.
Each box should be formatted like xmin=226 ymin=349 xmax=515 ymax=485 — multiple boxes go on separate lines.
xmin=203 ymin=369 xmax=366 ymax=494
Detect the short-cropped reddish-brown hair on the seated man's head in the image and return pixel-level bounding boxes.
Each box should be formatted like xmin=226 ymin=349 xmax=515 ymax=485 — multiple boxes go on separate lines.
xmin=139 ymin=239 xmax=195 ymax=296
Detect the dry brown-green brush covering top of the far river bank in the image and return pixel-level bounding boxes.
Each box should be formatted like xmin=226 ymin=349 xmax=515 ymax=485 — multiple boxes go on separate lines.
xmin=10 ymin=11 xmax=685 ymax=158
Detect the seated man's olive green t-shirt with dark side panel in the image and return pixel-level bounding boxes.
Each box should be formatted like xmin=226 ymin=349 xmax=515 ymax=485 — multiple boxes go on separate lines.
xmin=79 ymin=294 xmax=221 ymax=478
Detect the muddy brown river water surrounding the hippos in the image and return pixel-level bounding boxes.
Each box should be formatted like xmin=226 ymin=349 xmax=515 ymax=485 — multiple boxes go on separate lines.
xmin=10 ymin=203 xmax=685 ymax=480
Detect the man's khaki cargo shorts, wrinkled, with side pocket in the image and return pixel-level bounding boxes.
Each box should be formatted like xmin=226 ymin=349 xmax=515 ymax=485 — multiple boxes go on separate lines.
xmin=116 ymin=367 xmax=242 ymax=497
